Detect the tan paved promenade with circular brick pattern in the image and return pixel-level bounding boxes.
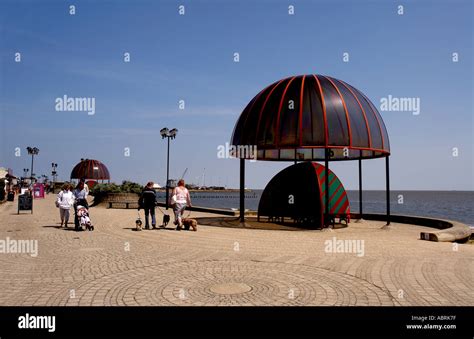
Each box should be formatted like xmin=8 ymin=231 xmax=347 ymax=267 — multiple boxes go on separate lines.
xmin=0 ymin=196 xmax=474 ymax=306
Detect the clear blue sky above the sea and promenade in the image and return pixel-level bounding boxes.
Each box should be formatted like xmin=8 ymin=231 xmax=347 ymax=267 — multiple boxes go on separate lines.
xmin=0 ymin=0 xmax=474 ymax=190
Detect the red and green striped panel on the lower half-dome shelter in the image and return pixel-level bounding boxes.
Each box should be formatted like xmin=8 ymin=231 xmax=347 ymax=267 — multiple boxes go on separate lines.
xmin=313 ymin=162 xmax=350 ymax=215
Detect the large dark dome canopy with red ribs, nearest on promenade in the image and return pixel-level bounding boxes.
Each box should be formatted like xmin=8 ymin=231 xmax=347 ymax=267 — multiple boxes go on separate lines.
xmin=231 ymin=74 xmax=390 ymax=161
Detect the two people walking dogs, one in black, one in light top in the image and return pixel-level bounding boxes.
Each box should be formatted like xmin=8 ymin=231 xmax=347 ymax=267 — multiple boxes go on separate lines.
xmin=138 ymin=179 xmax=192 ymax=231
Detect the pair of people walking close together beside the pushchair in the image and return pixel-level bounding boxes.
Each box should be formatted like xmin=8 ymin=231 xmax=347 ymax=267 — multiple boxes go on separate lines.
xmin=56 ymin=179 xmax=89 ymax=231
